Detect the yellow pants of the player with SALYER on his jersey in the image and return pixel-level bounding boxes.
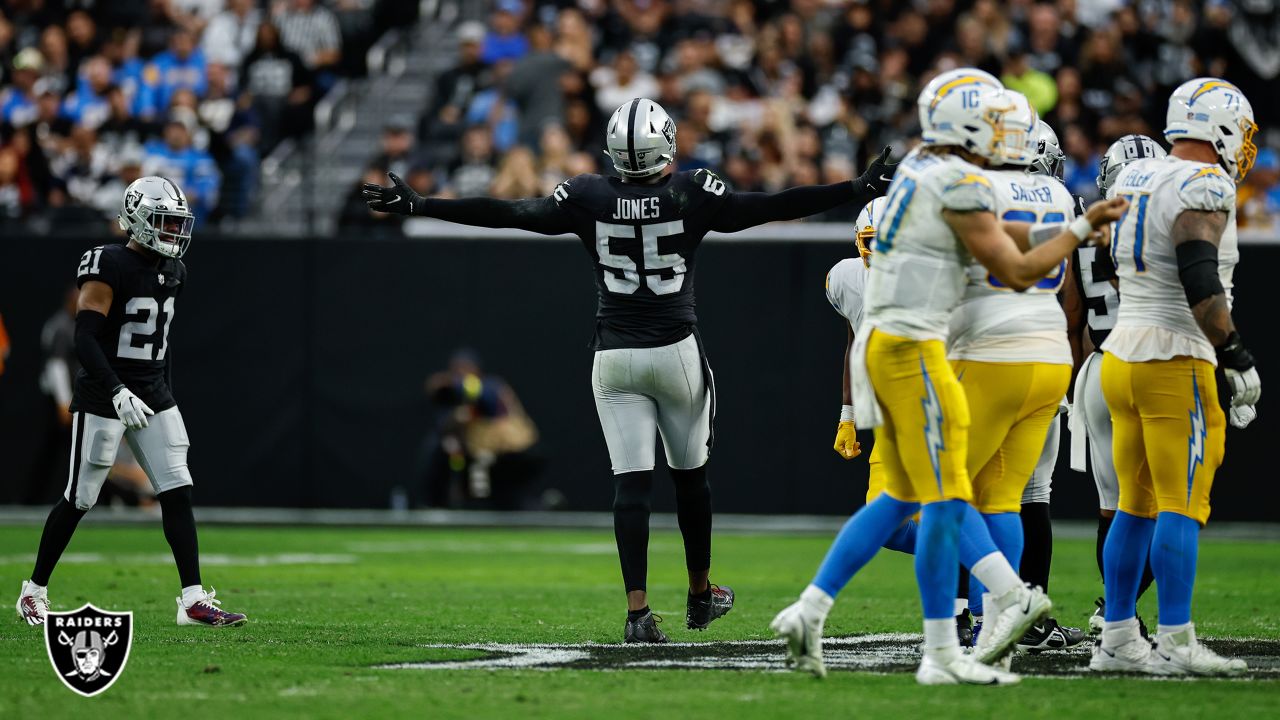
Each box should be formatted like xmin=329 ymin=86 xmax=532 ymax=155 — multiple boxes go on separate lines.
xmin=951 ymin=360 xmax=1071 ymax=514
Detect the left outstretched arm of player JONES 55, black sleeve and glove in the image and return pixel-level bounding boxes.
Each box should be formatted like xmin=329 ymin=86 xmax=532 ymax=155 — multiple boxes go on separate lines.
xmin=361 ymin=173 xmax=573 ymax=234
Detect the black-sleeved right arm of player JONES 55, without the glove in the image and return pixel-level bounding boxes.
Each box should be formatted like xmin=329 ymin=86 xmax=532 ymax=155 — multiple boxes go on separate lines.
xmin=712 ymin=179 xmax=877 ymax=232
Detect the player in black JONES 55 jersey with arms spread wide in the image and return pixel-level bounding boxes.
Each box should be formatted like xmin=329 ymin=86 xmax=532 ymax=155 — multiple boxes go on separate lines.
xmin=364 ymin=99 xmax=893 ymax=642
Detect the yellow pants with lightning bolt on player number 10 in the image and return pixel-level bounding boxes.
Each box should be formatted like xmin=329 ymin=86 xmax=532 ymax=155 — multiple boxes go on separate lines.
xmin=867 ymin=329 xmax=973 ymax=503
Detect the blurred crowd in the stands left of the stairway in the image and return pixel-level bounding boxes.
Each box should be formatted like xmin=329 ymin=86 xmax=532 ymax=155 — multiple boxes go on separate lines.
xmin=0 ymin=0 xmax=417 ymax=225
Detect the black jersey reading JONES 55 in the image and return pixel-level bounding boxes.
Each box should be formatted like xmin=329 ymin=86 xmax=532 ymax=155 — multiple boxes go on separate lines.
xmin=553 ymin=170 xmax=727 ymax=350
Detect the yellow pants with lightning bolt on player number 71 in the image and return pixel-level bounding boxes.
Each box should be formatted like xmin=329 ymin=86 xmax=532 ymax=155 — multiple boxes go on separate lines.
xmin=1102 ymin=352 xmax=1226 ymax=525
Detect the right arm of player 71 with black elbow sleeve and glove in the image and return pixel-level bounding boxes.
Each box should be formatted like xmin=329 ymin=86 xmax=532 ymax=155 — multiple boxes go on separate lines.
xmin=1170 ymin=210 xmax=1262 ymax=407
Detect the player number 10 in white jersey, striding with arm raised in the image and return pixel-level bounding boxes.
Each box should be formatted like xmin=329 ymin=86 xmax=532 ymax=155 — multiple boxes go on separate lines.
xmin=771 ymin=69 xmax=1124 ymax=684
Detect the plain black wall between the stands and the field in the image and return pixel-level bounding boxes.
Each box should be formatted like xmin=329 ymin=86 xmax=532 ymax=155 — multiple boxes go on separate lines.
xmin=0 ymin=234 xmax=1280 ymax=520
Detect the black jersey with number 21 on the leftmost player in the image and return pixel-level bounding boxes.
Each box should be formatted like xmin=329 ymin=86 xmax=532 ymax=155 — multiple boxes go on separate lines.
xmin=72 ymin=245 xmax=187 ymax=418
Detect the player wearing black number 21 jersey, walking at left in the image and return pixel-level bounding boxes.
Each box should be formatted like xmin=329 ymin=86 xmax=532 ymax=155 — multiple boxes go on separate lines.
xmin=18 ymin=177 xmax=246 ymax=626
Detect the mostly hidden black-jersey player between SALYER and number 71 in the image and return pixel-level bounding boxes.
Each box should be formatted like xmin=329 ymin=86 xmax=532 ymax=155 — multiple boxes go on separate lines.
xmin=1066 ymin=135 xmax=1166 ymax=633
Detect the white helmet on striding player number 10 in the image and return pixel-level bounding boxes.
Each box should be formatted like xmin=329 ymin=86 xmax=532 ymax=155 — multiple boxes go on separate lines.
xmin=922 ymin=82 xmax=1015 ymax=163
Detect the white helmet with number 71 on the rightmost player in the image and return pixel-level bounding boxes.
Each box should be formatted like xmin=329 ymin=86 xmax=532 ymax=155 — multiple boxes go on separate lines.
xmin=1165 ymin=77 xmax=1258 ymax=184
